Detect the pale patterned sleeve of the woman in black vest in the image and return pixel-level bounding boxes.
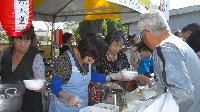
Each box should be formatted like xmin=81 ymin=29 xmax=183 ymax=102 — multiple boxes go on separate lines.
xmin=32 ymin=54 xmax=45 ymax=79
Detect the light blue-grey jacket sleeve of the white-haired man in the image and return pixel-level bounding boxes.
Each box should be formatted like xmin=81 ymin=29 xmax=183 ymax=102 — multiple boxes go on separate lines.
xmin=161 ymin=44 xmax=194 ymax=109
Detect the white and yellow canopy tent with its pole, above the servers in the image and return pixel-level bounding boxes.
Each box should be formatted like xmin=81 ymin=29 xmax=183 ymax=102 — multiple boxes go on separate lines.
xmin=33 ymin=0 xmax=149 ymax=58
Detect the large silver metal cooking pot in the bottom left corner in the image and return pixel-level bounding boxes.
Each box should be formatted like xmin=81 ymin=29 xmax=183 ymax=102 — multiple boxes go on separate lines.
xmin=0 ymin=84 xmax=25 ymax=112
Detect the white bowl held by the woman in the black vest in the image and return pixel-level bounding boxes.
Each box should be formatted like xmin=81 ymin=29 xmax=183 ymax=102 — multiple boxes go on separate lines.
xmin=23 ymin=79 xmax=45 ymax=90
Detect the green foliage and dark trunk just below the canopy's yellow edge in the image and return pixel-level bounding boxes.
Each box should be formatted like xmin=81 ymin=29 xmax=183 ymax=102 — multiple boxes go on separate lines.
xmin=64 ymin=19 xmax=128 ymax=37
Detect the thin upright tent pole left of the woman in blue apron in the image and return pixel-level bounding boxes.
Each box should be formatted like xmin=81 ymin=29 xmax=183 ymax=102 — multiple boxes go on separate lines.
xmin=51 ymin=16 xmax=56 ymax=62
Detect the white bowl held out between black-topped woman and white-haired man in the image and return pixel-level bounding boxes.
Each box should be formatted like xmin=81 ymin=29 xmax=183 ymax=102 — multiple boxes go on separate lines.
xmin=122 ymin=70 xmax=138 ymax=80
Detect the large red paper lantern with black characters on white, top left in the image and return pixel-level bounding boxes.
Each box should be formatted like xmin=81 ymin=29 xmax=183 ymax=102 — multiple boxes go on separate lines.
xmin=0 ymin=0 xmax=33 ymax=36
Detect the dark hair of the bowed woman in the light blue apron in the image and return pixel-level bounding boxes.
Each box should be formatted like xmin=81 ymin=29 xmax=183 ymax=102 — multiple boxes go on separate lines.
xmin=77 ymin=33 xmax=107 ymax=61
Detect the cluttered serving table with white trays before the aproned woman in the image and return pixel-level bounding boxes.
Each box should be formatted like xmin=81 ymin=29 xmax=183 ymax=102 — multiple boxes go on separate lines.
xmin=80 ymin=87 xmax=156 ymax=112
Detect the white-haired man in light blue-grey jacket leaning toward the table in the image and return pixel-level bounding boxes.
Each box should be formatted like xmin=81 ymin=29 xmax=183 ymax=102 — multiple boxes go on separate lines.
xmin=138 ymin=10 xmax=200 ymax=112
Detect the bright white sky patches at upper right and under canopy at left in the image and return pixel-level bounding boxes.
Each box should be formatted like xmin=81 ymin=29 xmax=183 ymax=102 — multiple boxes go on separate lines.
xmin=33 ymin=0 xmax=200 ymax=30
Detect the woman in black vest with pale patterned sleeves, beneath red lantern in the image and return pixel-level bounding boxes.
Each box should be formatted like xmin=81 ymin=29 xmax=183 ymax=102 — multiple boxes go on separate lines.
xmin=0 ymin=26 xmax=45 ymax=112
